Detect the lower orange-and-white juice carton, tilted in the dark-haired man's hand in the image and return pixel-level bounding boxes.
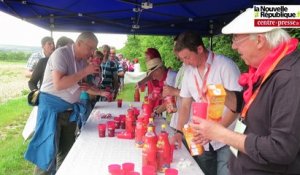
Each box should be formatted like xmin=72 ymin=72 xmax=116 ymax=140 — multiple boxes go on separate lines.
xmin=183 ymin=124 xmax=204 ymax=156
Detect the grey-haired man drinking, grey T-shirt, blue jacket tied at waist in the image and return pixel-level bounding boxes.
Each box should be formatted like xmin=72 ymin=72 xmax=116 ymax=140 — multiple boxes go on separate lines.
xmin=25 ymin=32 xmax=99 ymax=175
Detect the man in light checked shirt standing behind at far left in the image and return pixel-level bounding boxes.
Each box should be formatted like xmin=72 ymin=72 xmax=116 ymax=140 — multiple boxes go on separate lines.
xmin=25 ymin=36 xmax=55 ymax=78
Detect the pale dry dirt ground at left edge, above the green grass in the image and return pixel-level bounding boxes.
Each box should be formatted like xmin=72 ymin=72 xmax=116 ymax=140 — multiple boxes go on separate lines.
xmin=0 ymin=62 xmax=29 ymax=103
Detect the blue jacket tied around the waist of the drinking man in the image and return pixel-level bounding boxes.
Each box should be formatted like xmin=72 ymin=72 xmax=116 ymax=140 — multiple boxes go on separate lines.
xmin=25 ymin=92 xmax=86 ymax=170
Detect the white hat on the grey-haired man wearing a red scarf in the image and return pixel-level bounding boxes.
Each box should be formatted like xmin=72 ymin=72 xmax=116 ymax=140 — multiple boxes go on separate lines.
xmin=222 ymin=8 xmax=275 ymax=34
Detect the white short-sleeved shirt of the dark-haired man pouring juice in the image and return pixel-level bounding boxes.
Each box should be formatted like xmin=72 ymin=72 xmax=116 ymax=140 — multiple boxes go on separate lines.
xmin=180 ymin=52 xmax=242 ymax=151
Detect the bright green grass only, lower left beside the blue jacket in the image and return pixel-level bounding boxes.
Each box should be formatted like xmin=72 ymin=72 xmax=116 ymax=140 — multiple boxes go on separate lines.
xmin=0 ymin=96 xmax=33 ymax=175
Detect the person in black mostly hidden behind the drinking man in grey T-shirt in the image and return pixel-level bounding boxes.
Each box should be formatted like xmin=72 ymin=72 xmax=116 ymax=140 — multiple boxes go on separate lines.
xmin=28 ymin=36 xmax=74 ymax=91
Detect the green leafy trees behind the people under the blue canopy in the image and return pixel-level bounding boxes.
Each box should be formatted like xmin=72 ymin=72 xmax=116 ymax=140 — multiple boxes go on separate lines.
xmin=119 ymin=28 xmax=300 ymax=72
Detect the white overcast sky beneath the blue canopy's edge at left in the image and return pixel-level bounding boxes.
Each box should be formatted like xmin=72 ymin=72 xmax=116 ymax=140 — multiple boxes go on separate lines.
xmin=0 ymin=11 xmax=127 ymax=49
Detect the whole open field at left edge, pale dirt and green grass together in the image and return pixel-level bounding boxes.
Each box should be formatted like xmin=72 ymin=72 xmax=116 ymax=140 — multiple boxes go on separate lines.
xmin=0 ymin=61 xmax=33 ymax=175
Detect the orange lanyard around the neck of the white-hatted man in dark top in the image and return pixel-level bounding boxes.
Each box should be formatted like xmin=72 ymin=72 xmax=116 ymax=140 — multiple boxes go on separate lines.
xmin=241 ymin=46 xmax=288 ymax=120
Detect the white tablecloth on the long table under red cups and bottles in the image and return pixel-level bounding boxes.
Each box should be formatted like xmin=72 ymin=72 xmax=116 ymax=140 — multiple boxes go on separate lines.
xmin=56 ymin=102 xmax=203 ymax=175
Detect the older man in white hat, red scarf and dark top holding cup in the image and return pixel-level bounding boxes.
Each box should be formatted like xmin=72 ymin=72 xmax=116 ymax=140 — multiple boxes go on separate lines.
xmin=192 ymin=8 xmax=300 ymax=175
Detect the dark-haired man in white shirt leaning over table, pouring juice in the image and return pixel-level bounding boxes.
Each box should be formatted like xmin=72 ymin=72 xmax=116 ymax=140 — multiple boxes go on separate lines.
xmin=173 ymin=32 xmax=241 ymax=175
